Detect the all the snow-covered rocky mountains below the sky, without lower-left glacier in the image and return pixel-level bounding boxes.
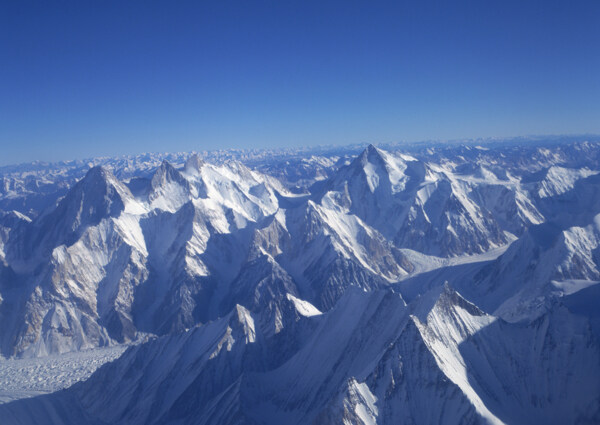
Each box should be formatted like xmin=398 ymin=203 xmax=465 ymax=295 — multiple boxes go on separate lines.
xmin=0 ymin=138 xmax=600 ymax=425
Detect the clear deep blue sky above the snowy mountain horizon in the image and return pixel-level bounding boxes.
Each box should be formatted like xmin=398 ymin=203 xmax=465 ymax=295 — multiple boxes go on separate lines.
xmin=0 ymin=0 xmax=600 ymax=164
